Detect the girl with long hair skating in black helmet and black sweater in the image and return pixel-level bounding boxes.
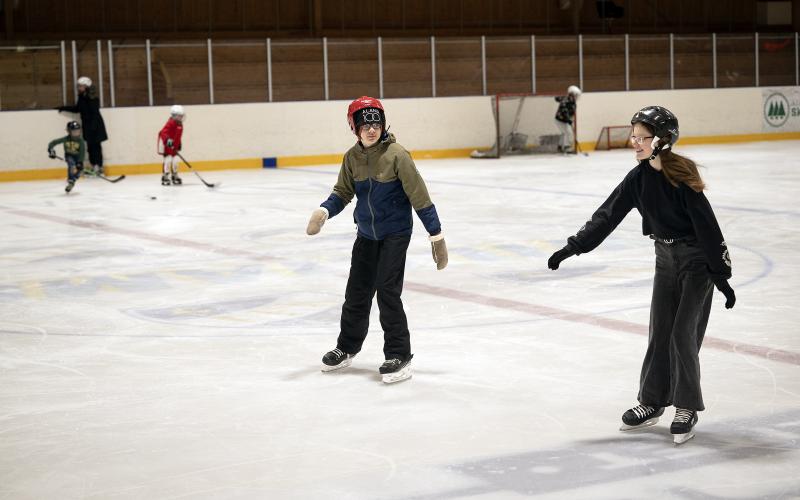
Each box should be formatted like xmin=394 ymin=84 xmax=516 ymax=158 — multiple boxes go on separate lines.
xmin=547 ymin=106 xmax=736 ymax=444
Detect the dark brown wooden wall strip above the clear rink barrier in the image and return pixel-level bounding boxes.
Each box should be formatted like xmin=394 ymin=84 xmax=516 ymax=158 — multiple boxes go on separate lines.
xmin=0 ymin=0 xmax=800 ymax=40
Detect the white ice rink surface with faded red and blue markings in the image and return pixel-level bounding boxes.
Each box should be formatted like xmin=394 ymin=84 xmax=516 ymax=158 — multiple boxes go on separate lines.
xmin=0 ymin=142 xmax=800 ymax=500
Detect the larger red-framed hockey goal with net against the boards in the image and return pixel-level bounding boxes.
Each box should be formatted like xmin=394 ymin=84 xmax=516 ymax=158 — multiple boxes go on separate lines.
xmin=471 ymin=94 xmax=576 ymax=158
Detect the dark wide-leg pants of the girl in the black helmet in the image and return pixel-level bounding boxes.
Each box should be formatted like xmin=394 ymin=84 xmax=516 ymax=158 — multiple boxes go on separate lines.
xmin=639 ymin=240 xmax=714 ymax=411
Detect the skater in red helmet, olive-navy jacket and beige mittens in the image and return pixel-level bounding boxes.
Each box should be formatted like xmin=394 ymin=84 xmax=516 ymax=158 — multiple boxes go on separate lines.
xmin=306 ymin=96 xmax=447 ymax=383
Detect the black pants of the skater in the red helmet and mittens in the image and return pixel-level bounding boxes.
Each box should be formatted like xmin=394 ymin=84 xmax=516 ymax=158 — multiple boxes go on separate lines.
xmin=336 ymin=236 xmax=411 ymax=360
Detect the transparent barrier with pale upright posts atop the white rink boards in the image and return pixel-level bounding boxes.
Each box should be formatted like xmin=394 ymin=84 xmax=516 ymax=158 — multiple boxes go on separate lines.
xmin=0 ymin=33 xmax=800 ymax=110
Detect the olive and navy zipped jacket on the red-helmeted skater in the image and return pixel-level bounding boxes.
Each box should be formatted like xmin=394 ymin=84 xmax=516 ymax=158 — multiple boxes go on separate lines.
xmin=320 ymin=133 xmax=442 ymax=240
